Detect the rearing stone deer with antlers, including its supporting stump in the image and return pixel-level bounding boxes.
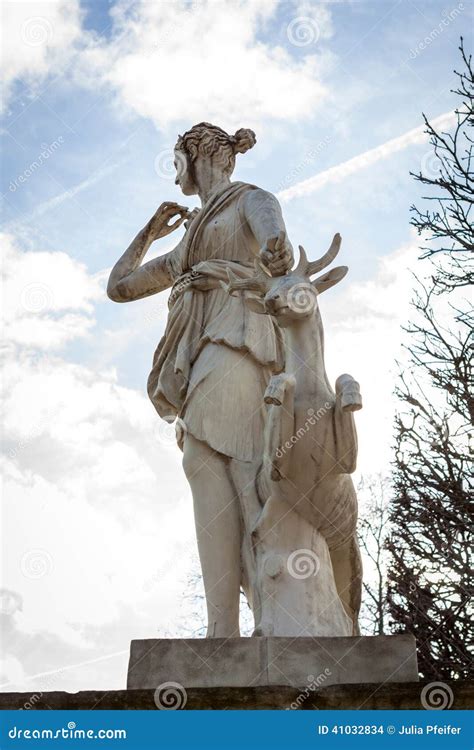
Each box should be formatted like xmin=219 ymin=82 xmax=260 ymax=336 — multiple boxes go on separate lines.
xmin=225 ymin=234 xmax=362 ymax=636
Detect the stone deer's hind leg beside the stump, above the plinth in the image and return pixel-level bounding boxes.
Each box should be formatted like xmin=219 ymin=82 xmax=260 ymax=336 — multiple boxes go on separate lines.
xmin=330 ymin=534 xmax=362 ymax=635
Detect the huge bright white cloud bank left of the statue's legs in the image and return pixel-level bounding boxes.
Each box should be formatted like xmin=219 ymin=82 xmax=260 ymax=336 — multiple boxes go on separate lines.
xmin=0 ymin=238 xmax=195 ymax=690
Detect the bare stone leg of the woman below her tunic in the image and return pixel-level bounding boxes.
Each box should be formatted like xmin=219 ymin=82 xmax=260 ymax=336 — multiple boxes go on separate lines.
xmin=183 ymin=433 xmax=241 ymax=638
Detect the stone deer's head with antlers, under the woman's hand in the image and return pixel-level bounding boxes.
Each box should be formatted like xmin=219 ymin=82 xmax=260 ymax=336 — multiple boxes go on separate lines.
xmin=223 ymin=234 xmax=348 ymax=328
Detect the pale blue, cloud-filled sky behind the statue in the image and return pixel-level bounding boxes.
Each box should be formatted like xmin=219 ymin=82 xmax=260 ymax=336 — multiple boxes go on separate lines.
xmin=1 ymin=0 xmax=473 ymax=689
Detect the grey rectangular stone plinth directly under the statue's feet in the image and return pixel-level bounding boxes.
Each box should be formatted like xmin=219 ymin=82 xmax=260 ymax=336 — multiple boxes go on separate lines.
xmin=127 ymin=635 xmax=418 ymax=690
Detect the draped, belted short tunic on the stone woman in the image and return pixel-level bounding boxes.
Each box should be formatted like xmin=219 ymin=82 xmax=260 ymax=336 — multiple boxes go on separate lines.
xmin=148 ymin=183 xmax=283 ymax=461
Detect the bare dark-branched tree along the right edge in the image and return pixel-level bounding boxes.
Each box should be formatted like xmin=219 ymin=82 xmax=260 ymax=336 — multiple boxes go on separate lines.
xmin=386 ymin=39 xmax=474 ymax=679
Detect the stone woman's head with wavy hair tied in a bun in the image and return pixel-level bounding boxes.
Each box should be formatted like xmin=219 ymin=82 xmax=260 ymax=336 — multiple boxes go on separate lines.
xmin=174 ymin=122 xmax=256 ymax=195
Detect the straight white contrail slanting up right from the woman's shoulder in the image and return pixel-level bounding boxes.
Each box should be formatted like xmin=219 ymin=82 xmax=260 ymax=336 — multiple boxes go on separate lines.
xmin=277 ymin=112 xmax=456 ymax=202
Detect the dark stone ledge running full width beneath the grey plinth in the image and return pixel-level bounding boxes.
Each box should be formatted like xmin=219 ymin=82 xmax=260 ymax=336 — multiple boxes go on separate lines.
xmin=0 ymin=680 xmax=474 ymax=712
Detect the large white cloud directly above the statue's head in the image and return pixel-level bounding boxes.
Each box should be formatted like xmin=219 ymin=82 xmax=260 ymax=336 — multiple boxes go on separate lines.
xmin=82 ymin=0 xmax=330 ymax=128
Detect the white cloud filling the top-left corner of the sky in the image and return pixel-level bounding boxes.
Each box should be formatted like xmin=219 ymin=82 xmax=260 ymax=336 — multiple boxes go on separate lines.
xmin=2 ymin=0 xmax=81 ymax=112
